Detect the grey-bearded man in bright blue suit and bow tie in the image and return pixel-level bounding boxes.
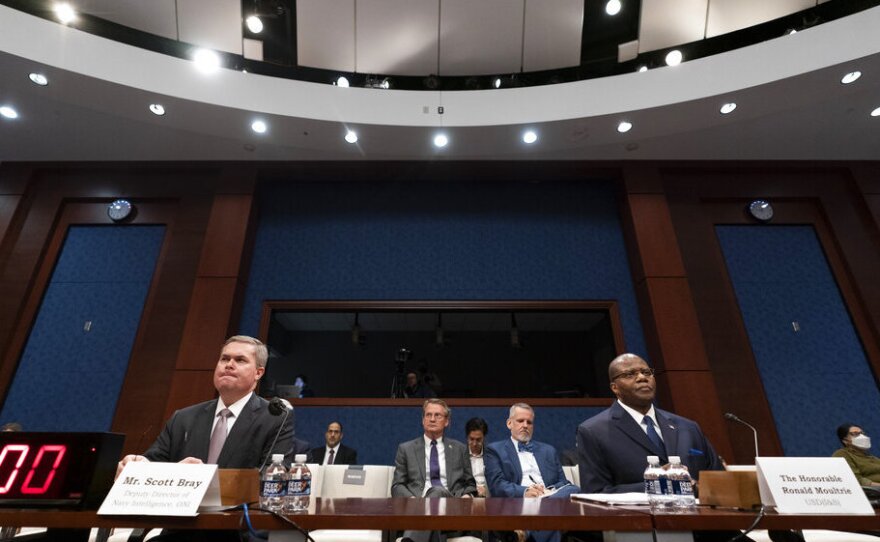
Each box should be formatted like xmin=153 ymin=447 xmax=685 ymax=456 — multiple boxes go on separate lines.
xmin=485 ymin=403 xmax=580 ymax=542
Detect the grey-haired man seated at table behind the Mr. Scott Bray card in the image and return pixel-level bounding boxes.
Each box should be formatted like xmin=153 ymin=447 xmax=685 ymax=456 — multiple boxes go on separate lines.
xmin=117 ymin=335 xmax=294 ymax=541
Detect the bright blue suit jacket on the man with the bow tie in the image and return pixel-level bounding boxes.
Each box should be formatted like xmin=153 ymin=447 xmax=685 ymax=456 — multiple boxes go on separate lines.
xmin=483 ymin=438 xmax=566 ymax=497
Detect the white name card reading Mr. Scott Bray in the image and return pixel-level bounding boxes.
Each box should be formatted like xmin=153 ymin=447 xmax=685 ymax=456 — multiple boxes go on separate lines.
xmin=98 ymin=461 xmax=220 ymax=516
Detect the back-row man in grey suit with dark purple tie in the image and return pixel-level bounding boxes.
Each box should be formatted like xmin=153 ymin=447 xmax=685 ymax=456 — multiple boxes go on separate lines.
xmin=391 ymin=398 xmax=477 ymax=541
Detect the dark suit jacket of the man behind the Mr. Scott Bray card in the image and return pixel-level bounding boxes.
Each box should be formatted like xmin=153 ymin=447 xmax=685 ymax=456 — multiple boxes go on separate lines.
xmin=144 ymin=394 xmax=294 ymax=468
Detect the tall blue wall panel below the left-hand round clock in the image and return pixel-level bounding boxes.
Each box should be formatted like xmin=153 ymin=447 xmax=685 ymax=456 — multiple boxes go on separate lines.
xmin=0 ymin=226 xmax=165 ymax=431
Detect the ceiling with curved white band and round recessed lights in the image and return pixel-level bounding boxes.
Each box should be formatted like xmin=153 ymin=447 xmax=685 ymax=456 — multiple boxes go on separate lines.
xmin=0 ymin=0 xmax=880 ymax=161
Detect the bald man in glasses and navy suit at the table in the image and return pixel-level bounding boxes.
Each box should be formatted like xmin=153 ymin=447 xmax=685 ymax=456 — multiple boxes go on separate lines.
xmin=577 ymin=354 xmax=722 ymax=493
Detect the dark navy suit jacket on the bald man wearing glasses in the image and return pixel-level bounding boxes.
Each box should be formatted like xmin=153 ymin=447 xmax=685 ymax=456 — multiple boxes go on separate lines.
xmin=577 ymin=401 xmax=722 ymax=493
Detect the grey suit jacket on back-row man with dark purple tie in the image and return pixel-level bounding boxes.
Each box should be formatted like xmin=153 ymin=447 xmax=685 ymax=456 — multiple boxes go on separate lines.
xmin=391 ymin=435 xmax=477 ymax=497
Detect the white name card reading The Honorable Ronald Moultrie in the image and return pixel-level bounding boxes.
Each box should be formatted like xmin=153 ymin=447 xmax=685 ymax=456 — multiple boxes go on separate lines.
xmin=755 ymin=457 xmax=874 ymax=515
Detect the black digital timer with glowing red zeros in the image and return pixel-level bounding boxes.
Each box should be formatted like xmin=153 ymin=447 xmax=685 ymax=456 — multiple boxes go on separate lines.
xmin=0 ymin=433 xmax=125 ymax=506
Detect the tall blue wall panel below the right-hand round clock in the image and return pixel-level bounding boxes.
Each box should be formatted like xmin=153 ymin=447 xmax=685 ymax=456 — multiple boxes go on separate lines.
xmin=716 ymin=226 xmax=880 ymax=456
